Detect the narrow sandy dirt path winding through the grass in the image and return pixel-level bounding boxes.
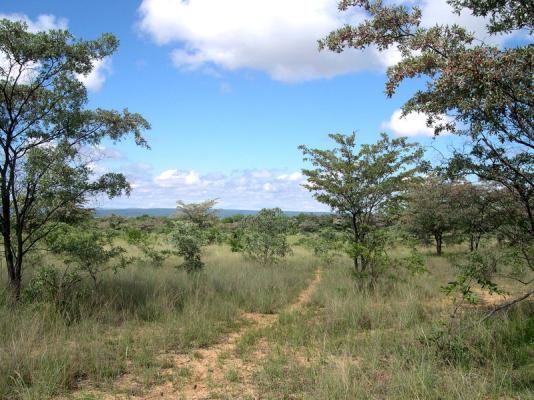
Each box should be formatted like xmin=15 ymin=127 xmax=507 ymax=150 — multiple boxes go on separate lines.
xmin=99 ymin=270 xmax=321 ymax=400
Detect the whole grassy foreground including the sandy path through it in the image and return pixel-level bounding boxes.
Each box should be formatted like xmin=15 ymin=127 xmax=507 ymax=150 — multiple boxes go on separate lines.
xmin=0 ymin=242 xmax=534 ymax=399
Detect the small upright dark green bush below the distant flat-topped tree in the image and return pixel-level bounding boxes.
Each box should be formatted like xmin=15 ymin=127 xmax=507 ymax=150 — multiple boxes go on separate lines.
xmin=171 ymin=220 xmax=207 ymax=272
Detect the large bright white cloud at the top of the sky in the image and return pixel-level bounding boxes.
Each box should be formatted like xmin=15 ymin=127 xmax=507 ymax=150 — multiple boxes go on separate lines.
xmin=139 ymin=0 xmax=520 ymax=82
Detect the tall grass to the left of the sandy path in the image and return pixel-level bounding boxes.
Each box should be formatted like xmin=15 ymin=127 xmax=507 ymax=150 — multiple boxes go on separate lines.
xmin=0 ymin=242 xmax=315 ymax=399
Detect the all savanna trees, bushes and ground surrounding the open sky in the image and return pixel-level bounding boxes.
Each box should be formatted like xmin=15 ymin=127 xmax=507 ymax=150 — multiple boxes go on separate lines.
xmin=0 ymin=0 xmax=534 ymax=400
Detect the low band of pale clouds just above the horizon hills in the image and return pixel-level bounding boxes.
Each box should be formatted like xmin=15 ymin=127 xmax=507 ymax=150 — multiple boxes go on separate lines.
xmin=99 ymin=164 xmax=327 ymax=211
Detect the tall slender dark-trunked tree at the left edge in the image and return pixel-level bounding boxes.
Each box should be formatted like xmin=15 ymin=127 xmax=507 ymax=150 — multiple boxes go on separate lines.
xmin=0 ymin=19 xmax=150 ymax=299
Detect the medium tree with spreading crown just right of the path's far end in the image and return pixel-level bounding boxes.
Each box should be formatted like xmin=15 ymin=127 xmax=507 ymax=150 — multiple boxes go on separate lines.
xmin=300 ymin=133 xmax=426 ymax=272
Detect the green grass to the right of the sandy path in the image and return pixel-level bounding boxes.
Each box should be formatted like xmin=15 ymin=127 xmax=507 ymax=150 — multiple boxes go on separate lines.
xmin=255 ymin=250 xmax=534 ymax=399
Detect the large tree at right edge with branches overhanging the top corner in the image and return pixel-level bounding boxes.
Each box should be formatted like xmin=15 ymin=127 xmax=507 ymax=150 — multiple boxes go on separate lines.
xmin=319 ymin=0 xmax=534 ymax=310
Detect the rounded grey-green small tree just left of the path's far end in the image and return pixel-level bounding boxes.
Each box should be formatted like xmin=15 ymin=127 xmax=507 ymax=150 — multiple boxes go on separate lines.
xmin=242 ymin=208 xmax=291 ymax=265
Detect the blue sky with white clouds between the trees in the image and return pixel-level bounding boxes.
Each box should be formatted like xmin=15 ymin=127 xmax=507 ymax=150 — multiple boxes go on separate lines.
xmin=0 ymin=0 xmax=520 ymax=211
